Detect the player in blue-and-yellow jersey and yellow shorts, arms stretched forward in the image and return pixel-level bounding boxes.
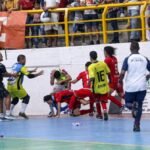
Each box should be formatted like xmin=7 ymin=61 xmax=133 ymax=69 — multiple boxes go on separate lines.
xmin=7 ymin=55 xmax=43 ymax=119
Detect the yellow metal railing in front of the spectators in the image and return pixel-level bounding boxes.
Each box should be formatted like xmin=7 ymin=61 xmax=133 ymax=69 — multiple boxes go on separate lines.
xmin=22 ymin=1 xmax=150 ymax=46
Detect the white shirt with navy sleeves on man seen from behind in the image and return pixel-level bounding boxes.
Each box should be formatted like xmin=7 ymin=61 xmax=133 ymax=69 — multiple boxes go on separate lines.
xmin=122 ymin=54 xmax=150 ymax=92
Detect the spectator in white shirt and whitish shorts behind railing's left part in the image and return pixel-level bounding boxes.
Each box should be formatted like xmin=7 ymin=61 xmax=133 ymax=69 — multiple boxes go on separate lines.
xmin=43 ymin=0 xmax=60 ymax=47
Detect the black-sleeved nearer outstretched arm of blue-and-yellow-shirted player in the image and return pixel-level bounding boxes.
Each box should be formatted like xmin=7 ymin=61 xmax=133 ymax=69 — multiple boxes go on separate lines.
xmin=21 ymin=66 xmax=43 ymax=79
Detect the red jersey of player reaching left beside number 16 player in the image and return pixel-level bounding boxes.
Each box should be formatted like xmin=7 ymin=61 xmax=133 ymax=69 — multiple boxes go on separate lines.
xmin=77 ymin=71 xmax=90 ymax=88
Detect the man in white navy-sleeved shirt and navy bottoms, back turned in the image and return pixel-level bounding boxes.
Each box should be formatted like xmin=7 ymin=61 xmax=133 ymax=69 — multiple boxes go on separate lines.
xmin=120 ymin=41 xmax=150 ymax=132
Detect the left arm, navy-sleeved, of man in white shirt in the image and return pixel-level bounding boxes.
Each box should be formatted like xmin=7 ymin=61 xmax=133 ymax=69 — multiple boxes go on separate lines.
xmin=119 ymin=58 xmax=128 ymax=84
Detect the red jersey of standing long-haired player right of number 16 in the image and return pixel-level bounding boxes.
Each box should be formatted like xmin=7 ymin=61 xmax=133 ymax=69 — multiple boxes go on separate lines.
xmin=105 ymin=56 xmax=119 ymax=83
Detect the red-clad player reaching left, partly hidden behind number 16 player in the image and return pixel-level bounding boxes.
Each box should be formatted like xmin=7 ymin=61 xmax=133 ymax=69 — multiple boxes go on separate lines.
xmin=71 ymin=62 xmax=94 ymax=116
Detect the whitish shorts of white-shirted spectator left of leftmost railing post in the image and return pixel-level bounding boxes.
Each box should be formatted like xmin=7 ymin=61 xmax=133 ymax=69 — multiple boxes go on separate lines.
xmin=45 ymin=13 xmax=59 ymax=31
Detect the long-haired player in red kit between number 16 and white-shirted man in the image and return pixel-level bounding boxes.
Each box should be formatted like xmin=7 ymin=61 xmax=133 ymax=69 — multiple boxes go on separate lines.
xmin=104 ymin=46 xmax=124 ymax=108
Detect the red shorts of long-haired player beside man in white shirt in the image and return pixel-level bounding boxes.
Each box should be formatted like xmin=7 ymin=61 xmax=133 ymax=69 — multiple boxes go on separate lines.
xmin=109 ymin=82 xmax=124 ymax=94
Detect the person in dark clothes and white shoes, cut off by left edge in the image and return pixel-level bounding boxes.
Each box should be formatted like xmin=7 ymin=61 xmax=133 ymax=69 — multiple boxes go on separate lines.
xmin=0 ymin=52 xmax=17 ymax=120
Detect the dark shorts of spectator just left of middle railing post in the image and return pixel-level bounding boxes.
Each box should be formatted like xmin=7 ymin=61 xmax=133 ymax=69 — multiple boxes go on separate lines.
xmin=84 ymin=14 xmax=99 ymax=28
